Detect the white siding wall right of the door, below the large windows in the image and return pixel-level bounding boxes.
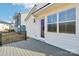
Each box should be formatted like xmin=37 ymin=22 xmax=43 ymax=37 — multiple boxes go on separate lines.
xmin=45 ymin=4 xmax=79 ymax=54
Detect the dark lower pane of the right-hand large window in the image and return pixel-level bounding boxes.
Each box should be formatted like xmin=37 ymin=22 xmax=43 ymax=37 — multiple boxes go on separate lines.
xmin=59 ymin=22 xmax=75 ymax=34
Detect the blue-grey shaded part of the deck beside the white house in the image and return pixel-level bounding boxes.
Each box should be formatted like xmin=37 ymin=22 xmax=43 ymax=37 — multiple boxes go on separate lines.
xmin=4 ymin=39 xmax=78 ymax=56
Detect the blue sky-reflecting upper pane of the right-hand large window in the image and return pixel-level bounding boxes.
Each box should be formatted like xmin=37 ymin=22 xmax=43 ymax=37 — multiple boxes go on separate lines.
xmin=59 ymin=8 xmax=76 ymax=21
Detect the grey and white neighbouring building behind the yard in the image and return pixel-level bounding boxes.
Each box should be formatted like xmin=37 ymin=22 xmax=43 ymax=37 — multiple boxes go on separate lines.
xmin=12 ymin=13 xmax=27 ymax=32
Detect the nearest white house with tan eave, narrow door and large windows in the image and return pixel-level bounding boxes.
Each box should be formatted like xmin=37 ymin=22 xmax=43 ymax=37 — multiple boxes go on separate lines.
xmin=26 ymin=3 xmax=79 ymax=54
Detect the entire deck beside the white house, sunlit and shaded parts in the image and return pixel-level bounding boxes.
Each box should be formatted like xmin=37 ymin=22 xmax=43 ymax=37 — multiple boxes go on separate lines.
xmin=0 ymin=39 xmax=77 ymax=56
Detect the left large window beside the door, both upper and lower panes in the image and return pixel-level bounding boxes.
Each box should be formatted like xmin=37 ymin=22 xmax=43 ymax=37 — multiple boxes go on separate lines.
xmin=48 ymin=14 xmax=57 ymax=32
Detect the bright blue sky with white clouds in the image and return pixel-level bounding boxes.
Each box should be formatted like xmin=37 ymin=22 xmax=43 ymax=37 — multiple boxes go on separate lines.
xmin=0 ymin=3 xmax=34 ymax=22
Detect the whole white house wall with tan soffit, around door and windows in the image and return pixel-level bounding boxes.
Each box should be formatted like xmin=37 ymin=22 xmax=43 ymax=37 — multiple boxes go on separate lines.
xmin=26 ymin=4 xmax=79 ymax=54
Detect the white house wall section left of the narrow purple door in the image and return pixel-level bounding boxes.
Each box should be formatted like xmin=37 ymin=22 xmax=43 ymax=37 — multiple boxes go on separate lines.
xmin=26 ymin=15 xmax=45 ymax=41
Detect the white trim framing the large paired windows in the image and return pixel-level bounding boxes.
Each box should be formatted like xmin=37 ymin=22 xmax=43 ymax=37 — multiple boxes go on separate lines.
xmin=47 ymin=7 xmax=76 ymax=35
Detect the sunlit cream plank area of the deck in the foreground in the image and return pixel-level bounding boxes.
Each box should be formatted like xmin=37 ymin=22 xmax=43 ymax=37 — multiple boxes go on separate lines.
xmin=0 ymin=46 xmax=44 ymax=56
